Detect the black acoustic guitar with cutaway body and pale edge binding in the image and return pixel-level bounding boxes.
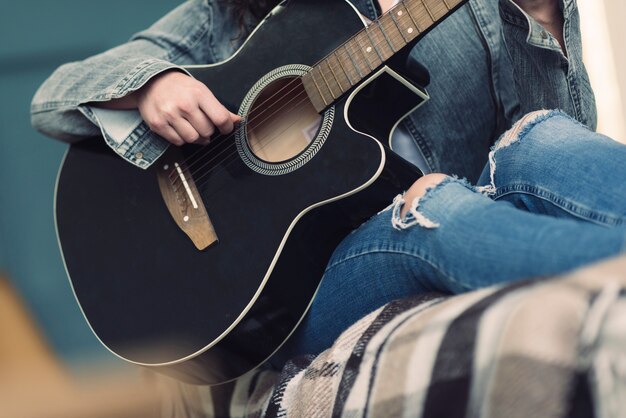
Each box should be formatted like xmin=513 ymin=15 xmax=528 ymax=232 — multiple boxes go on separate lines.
xmin=56 ymin=0 xmax=465 ymax=384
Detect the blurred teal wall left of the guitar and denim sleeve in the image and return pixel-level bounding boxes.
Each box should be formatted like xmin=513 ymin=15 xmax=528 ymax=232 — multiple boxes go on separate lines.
xmin=0 ymin=0 xmax=180 ymax=366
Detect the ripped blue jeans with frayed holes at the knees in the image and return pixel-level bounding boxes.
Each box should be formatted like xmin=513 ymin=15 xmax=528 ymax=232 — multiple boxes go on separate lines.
xmin=272 ymin=111 xmax=626 ymax=364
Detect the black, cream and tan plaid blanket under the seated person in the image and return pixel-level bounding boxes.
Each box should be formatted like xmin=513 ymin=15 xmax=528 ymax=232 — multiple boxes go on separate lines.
xmin=158 ymin=257 xmax=626 ymax=418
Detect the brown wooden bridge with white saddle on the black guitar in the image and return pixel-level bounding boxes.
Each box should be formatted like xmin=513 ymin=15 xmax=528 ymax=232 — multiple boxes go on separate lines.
xmin=157 ymin=147 xmax=217 ymax=250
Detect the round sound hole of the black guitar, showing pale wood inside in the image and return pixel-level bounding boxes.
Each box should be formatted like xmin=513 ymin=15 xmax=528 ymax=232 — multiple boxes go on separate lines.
xmin=247 ymin=77 xmax=322 ymax=162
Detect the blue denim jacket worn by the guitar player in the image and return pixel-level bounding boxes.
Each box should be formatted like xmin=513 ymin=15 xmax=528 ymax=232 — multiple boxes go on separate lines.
xmin=31 ymin=0 xmax=596 ymax=179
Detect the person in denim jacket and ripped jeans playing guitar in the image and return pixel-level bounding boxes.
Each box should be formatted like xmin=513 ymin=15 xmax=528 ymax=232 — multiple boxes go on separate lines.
xmin=31 ymin=0 xmax=626 ymax=367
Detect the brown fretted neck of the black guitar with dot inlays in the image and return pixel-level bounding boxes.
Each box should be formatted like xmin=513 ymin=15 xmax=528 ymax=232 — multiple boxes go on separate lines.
xmin=302 ymin=0 xmax=466 ymax=112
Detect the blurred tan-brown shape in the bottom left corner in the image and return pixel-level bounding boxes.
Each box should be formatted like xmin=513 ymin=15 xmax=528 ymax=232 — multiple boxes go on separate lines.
xmin=0 ymin=276 xmax=160 ymax=418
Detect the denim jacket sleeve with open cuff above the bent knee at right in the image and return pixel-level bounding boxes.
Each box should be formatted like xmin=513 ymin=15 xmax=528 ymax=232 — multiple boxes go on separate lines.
xmin=500 ymin=0 xmax=597 ymax=129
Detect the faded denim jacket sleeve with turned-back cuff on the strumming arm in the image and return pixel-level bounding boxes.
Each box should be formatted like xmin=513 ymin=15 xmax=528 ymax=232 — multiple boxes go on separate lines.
xmin=31 ymin=0 xmax=222 ymax=168
